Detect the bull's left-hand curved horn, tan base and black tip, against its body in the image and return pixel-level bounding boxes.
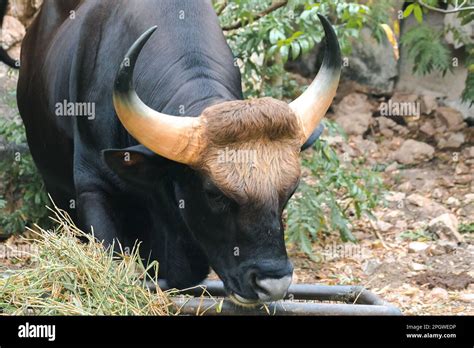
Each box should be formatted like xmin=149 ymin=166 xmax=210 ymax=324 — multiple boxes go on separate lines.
xmin=113 ymin=26 xmax=206 ymax=164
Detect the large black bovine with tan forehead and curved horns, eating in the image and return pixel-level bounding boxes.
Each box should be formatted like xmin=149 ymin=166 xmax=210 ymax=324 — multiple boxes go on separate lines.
xmin=18 ymin=0 xmax=340 ymax=304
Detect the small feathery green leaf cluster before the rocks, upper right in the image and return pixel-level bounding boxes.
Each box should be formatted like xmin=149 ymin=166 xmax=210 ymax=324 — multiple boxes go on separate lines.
xmin=401 ymin=24 xmax=451 ymax=75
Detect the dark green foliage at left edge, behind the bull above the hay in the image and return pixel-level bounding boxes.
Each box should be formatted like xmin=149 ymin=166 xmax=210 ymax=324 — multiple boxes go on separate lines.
xmin=0 ymin=120 xmax=50 ymax=237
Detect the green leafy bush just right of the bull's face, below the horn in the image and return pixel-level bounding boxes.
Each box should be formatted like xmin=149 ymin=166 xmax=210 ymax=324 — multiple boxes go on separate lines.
xmin=287 ymin=122 xmax=383 ymax=255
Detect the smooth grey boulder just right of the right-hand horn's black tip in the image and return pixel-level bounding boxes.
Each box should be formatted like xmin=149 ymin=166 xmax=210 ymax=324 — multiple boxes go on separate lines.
xmin=343 ymin=28 xmax=398 ymax=95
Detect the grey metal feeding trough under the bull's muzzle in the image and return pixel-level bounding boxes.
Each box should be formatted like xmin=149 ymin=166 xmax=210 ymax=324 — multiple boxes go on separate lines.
xmin=150 ymin=280 xmax=402 ymax=316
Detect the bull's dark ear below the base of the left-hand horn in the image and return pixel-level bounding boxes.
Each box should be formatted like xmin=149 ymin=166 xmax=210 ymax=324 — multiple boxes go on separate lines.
xmin=102 ymin=145 xmax=177 ymax=188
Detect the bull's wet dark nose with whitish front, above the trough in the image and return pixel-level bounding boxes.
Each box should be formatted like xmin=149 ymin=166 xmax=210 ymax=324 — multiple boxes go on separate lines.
xmin=247 ymin=261 xmax=293 ymax=302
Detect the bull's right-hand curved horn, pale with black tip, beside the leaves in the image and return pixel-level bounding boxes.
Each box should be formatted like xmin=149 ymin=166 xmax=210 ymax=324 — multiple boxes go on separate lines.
xmin=290 ymin=14 xmax=342 ymax=144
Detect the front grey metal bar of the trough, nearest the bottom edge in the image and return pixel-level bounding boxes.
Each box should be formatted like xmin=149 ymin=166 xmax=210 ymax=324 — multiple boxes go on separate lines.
xmin=173 ymin=297 xmax=401 ymax=316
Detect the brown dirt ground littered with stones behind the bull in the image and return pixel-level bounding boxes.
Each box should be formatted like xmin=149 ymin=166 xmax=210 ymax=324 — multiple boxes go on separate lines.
xmin=0 ymin=66 xmax=474 ymax=315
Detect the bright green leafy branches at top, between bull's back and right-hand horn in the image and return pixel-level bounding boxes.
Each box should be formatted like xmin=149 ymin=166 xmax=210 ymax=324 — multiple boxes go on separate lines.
xmin=215 ymin=0 xmax=369 ymax=97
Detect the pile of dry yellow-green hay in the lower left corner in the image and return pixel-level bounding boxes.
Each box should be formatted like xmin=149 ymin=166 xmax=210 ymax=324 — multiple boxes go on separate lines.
xmin=0 ymin=208 xmax=175 ymax=315
